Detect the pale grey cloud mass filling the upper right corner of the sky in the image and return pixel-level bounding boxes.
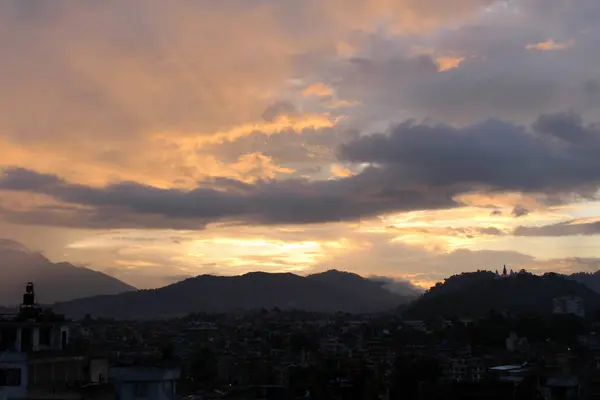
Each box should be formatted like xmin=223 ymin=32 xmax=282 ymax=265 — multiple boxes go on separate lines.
xmin=324 ymin=0 xmax=600 ymax=125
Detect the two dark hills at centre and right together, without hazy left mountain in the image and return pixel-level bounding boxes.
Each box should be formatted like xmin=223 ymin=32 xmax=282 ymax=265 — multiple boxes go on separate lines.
xmin=55 ymin=270 xmax=600 ymax=319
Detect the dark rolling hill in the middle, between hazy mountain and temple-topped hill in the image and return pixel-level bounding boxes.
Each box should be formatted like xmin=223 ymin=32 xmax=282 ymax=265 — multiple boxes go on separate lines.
xmin=54 ymin=271 xmax=414 ymax=319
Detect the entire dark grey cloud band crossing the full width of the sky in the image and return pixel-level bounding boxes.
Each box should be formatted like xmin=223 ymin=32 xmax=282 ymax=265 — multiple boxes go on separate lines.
xmin=0 ymin=113 xmax=600 ymax=229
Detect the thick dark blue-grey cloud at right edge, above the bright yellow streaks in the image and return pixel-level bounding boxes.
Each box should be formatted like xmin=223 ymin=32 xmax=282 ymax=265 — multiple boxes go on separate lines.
xmin=339 ymin=113 xmax=600 ymax=195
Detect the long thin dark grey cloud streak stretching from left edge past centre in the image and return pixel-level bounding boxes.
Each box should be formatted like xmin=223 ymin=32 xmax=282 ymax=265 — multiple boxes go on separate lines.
xmin=0 ymin=168 xmax=458 ymax=229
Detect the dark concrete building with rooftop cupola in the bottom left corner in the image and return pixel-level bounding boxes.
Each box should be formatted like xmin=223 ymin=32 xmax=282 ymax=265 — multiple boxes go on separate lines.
xmin=0 ymin=283 xmax=108 ymax=400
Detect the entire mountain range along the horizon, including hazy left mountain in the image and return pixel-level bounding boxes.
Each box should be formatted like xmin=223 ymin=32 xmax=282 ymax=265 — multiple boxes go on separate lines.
xmin=8 ymin=239 xmax=600 ymax=319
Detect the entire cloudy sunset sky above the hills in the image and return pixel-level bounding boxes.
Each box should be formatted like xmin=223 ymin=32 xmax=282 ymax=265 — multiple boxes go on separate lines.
xmin=0 ymin=0 xmax=600 ymax=288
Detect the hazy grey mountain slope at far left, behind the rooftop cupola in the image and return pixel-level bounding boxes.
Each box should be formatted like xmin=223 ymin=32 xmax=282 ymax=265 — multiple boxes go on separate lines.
xmin=0 ymin=239 xmax=135 ymax=306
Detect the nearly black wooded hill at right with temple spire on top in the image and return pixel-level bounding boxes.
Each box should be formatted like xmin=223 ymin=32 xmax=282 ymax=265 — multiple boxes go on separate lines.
xmin=404 ymin=271 xmax=600 ymax=319
